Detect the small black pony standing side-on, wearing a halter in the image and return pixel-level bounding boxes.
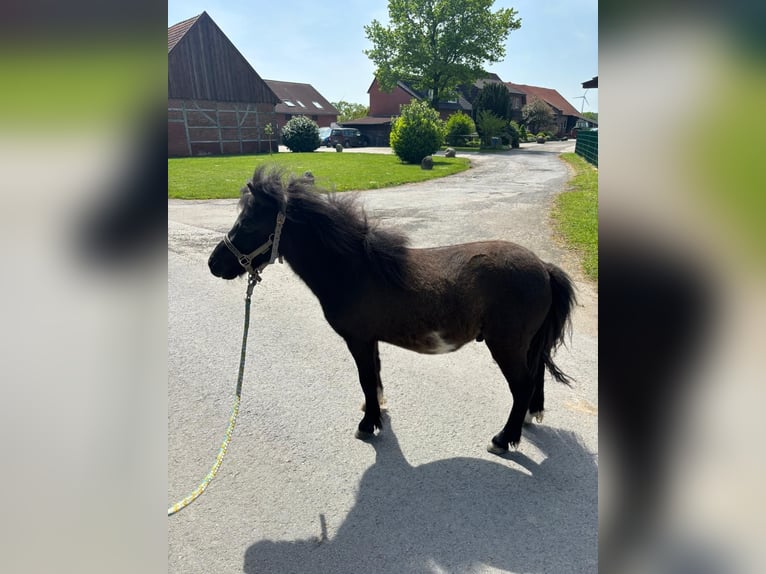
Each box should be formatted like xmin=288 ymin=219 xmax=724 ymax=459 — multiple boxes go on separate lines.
xmin=208 ymin=167 xmax=575 ymax=454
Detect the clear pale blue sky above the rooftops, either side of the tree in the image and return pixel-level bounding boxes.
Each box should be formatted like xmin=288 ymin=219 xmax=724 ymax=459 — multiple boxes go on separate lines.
xmin=168 ymin=0 xmax=598 ymax=112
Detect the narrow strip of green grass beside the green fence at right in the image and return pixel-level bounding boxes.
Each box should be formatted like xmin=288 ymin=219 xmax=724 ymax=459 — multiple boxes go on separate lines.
xmin=553 ymin=153 xmax=598 ymax=281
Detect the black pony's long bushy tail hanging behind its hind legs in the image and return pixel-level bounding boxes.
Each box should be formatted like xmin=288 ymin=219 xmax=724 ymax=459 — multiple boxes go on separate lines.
xmin=529 ymin=263 xmax=577 ymax=385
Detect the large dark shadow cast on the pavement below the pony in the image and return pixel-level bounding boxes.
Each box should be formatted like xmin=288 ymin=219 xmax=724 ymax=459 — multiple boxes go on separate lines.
xmin=244 ymin=421 xmax=598 ymax=574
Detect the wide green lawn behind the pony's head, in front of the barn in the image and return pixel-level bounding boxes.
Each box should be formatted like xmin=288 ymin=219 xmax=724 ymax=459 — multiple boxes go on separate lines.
xmin=168 ymin=152 xmax=470 ymax=199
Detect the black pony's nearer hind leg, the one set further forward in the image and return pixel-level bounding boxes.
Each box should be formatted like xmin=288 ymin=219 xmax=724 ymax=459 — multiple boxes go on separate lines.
xmin=487 ymin=339 xmax=542 ymax=454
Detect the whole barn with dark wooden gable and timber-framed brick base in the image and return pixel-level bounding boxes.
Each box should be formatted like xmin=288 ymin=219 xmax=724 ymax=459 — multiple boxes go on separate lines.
xmin=168 ymin=12 xmax=280 ymax=157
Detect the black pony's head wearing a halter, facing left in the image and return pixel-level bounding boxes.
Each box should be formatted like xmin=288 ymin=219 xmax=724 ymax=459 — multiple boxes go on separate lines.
xmin=208 ymin=166 xmax=286 ymax=279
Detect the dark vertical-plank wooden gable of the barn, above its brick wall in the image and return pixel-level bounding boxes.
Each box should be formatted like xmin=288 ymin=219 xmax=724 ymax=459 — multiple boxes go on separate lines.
xmin=168 ymin=19 xmax=278 ymax=106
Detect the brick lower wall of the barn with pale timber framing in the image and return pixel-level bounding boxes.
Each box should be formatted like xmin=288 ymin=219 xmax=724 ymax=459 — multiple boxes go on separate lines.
xmin=168 ymin=99 xmax=279 ymax=157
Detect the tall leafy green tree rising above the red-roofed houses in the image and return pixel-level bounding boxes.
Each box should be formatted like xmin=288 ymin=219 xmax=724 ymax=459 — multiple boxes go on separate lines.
xmin=364 ymin=0 xmax=521 ymax=109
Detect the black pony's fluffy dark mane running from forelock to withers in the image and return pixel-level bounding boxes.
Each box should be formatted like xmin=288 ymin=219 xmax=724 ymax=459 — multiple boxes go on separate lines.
xmin=240 ymin=166 xmax=409 ymax=285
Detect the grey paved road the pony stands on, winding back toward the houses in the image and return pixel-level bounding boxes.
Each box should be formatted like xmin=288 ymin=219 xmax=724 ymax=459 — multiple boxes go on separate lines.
xmin=168 ymin=142 xmax=598 ymax=574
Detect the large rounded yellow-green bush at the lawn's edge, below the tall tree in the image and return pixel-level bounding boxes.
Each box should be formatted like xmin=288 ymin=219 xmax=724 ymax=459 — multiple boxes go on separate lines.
xmin=389 ymin=100 xmax=444 ymax=163
